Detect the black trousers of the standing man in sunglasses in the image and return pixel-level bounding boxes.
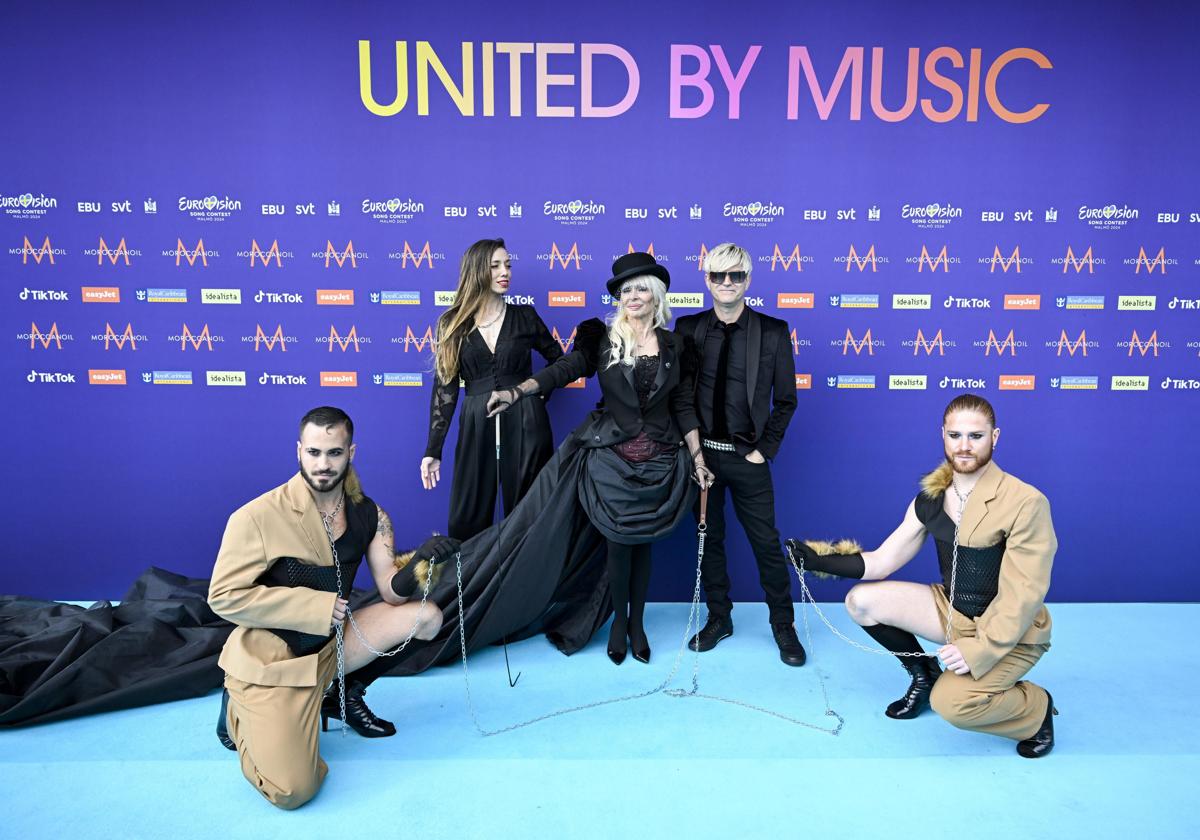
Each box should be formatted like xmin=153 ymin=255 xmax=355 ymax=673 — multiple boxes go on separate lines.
xmin=695 ymin=448 xmax=796 ymax=624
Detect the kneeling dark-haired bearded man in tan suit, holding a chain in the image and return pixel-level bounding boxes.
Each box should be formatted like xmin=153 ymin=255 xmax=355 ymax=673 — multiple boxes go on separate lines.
xmin=209 ymin=407 xmax=448 ymax=809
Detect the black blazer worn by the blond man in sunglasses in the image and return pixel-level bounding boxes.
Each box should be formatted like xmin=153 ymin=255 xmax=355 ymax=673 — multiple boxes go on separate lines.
xmin=676 ymin=307 xmax=796 ymax=458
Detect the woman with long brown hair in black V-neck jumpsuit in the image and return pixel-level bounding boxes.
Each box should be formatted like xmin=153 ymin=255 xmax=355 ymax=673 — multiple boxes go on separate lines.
xmin=421 ymin=239 xmax=563 ymax=540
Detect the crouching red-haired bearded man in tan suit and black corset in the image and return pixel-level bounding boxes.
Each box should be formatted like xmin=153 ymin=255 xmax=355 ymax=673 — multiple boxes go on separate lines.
xmin=787 ymin=394 xmax=1058 ymax=758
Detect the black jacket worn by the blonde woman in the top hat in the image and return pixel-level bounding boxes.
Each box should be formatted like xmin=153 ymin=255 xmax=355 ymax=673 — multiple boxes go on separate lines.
xmin=533 ymin=318 xmax=700 ymax=449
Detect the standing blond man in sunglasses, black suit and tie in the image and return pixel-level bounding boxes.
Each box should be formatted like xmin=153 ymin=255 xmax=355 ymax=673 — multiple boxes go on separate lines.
xmin=674 ymin=242 xmax=805 ymax=666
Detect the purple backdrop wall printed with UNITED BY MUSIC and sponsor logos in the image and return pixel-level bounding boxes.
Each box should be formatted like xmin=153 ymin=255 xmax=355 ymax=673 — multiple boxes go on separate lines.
xmin=0 ymin=2 xmax=1200 ymax=600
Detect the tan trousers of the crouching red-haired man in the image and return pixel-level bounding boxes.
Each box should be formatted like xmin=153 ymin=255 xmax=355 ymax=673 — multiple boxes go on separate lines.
xmin=929 ymin=583 xmax=1050 ymax=740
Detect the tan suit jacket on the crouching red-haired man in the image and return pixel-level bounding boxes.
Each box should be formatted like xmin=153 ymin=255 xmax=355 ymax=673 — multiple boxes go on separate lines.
xmin=954 ymin=462 xmax=1058 ymax=678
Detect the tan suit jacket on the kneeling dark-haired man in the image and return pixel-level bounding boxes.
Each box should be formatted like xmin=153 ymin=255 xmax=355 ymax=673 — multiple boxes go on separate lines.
xmin=209 ymin=473 xmax=337 ymax=686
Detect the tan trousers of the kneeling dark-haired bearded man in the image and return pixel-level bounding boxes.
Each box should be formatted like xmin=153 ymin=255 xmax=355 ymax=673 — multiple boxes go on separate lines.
xmin=226 ymin=642 xmax=337 ymax=810
